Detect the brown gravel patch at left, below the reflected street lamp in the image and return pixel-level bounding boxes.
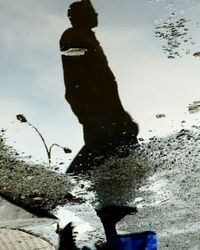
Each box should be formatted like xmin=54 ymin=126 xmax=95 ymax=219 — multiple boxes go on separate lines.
xmin=0 ymin=137 xmax=73 ymax=216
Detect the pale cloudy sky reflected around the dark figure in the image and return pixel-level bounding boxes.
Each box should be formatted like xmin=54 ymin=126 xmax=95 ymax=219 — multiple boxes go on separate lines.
xmin=0 ymin=0 xmax=200 ymax=169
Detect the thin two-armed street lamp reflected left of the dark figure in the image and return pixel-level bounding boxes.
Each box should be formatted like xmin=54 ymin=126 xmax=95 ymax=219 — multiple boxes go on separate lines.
xmin=16 ymin=114 xmax=72 ymax=167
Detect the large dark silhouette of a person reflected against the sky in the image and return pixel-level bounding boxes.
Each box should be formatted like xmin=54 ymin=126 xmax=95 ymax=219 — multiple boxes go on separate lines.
xmin=60 ymin=0 xmax=138 ymax=173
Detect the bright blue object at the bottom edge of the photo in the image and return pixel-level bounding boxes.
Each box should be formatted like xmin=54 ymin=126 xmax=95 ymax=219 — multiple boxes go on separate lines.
xmin=110 ymin=231 xmax=157 ymax=250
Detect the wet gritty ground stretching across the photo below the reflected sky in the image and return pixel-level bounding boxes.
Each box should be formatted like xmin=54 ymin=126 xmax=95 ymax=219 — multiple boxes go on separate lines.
xmin=0 ymin=126 xmax=200 ymax=250
